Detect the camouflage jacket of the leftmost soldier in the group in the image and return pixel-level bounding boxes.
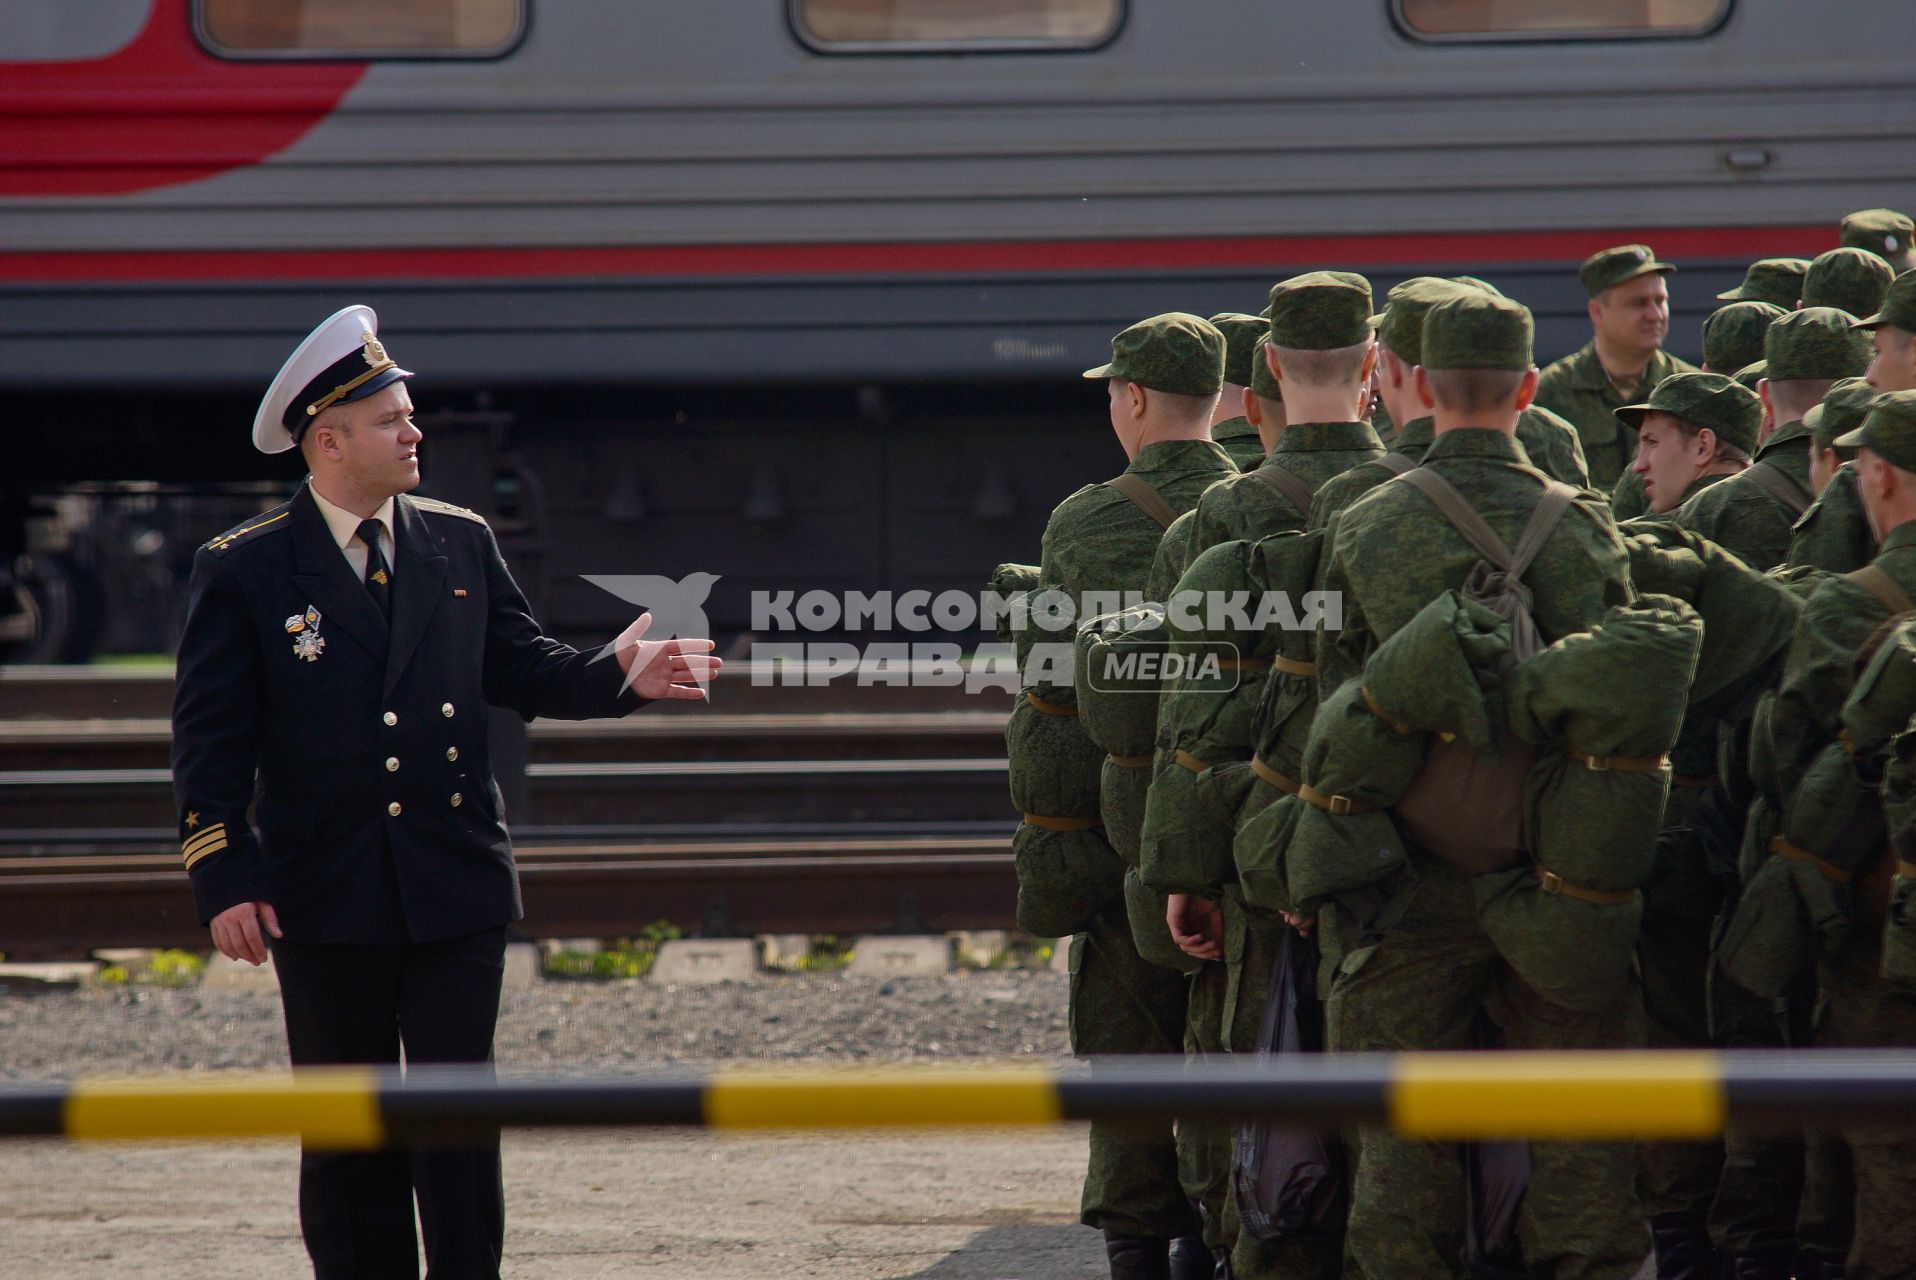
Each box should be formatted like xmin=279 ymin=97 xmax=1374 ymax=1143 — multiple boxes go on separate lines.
xmin=1031 ymin=441 xmax=1238 ymax=705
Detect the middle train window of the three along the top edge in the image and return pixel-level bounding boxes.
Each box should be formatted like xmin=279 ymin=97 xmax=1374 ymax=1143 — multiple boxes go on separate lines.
xmin=789 ymin=0 xmax=1125 ymax=54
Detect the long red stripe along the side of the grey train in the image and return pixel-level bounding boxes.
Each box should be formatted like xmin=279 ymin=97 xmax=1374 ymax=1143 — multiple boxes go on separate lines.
xmin=0 ymin=226 xmax=1837 ymax=284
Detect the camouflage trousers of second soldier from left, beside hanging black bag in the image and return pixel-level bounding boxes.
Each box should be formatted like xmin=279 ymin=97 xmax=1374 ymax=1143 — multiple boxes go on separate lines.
xmin=1178 ymin=891 xmax=1339 ymax=1280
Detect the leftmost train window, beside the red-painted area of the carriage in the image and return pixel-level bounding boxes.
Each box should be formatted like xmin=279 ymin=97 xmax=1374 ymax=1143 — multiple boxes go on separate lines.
xmin=195 ymin=0 xmax=525 ymax=57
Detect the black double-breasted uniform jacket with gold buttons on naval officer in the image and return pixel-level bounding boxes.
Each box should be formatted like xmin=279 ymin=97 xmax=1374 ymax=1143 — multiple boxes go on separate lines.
xmin=172 ymin=487 xmax=642 ymax=943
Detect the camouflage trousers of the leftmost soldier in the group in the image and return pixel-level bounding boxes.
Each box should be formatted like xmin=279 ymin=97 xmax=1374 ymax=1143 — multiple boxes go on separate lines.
xmin=1069 ymin=904 xmax=1198 ymax=1240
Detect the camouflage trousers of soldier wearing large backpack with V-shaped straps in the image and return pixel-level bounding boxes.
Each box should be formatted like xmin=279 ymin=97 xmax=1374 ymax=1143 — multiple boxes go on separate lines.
xmin=1326 ymin=853 xmax=1650 ymax=1280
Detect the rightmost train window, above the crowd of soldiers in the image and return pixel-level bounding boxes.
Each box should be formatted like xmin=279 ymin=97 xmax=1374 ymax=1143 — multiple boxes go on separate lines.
xmin=1395 ymin=0 xmax=1730 ymax=40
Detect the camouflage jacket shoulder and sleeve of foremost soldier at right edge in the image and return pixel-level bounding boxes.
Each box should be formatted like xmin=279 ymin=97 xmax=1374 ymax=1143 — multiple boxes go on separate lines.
xmin=1770 ymin=521 xmax=1916 ymax=795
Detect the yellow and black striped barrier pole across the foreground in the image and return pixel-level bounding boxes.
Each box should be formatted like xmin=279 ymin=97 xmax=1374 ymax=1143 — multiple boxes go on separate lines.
xmin=0 ymin=1050 xmax=1916 ymax=1150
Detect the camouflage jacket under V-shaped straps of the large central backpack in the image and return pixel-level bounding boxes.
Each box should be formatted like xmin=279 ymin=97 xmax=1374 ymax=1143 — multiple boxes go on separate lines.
xmin=1316 ymin=429 xmax=1631 ymax=696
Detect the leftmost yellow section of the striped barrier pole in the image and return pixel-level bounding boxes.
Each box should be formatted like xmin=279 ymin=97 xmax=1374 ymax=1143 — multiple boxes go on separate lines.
xmin=65 ymin=1067 xmax=385 ymax=1150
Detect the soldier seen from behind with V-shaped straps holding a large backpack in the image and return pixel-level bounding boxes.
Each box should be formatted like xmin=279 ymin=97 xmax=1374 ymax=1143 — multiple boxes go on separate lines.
xmin=1318 ymin=293 xmax=1650 ymax=1280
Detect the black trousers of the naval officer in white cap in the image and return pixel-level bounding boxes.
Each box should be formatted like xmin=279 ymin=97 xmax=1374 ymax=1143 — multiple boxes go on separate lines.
xmin=272 ymin=926 xmax=506 ymax=1280
